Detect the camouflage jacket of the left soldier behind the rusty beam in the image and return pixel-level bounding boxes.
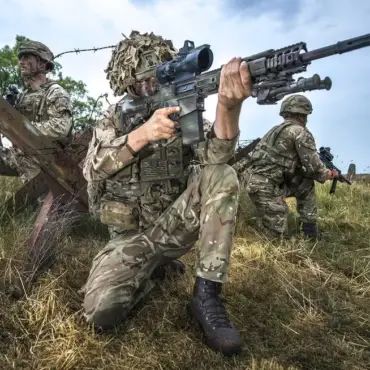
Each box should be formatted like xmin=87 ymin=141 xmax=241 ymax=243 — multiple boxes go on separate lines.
xmin=15 ymin=81 xmax=72 ymax=139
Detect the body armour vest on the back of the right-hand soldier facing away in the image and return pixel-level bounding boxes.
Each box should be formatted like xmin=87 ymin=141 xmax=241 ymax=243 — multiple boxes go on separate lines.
xmin=250 ymin=121 xmax=298 ymax=177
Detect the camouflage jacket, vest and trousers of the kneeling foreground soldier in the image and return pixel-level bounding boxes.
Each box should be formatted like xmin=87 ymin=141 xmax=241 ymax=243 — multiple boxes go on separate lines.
xmin=84 ymin=101 xmax=239 ymax=327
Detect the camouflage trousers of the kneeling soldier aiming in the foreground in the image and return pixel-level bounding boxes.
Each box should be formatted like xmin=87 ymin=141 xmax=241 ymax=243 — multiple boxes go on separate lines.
xmin=83 ymin=165 xmax=239 ymax=329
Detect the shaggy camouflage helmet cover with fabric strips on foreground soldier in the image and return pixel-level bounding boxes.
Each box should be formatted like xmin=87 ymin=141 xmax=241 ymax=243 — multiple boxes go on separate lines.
xmin=104 ymin=31 xmax=178 ymax=96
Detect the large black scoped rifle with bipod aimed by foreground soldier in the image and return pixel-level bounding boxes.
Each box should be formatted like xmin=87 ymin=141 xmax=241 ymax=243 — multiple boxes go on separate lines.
xmin=121 ymin=34 xmax=370 ymax=145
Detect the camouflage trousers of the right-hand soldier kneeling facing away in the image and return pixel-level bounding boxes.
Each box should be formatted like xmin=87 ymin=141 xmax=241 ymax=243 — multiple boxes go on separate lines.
xmin=246 ymin=174 xmax=317 ymax=236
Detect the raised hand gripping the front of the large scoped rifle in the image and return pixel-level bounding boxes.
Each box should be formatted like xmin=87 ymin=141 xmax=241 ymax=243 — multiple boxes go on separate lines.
xmin=218 ymin=58 xmax=252 ymax=109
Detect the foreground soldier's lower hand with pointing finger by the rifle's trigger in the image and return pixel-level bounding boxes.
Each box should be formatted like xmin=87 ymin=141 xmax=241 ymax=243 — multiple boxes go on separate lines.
xmin=143 ymin=107 xmax=180 ymax=141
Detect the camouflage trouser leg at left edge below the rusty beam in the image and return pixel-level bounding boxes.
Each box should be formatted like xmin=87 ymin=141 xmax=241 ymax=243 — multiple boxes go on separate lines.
xmin=0 ymin=148 xmax=40 ymax=183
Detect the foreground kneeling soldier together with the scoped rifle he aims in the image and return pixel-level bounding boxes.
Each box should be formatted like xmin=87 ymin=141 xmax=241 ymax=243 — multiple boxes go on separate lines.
xmin=80 ymin=31 xmax=370 ymax=355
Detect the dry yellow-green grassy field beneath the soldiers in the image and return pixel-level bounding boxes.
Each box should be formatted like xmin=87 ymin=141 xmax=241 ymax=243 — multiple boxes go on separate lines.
xmin=0 ymin=177 xmax=370 ymax=370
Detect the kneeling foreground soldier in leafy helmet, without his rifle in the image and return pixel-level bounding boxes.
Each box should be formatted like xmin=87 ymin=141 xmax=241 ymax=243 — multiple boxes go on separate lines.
xmin=83 ymin=31 xmax=251 ymax=355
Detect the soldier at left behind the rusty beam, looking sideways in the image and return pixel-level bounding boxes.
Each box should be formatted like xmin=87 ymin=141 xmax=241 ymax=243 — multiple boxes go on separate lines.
xmin=0 ymin=41 xmax=72 ymax=182
